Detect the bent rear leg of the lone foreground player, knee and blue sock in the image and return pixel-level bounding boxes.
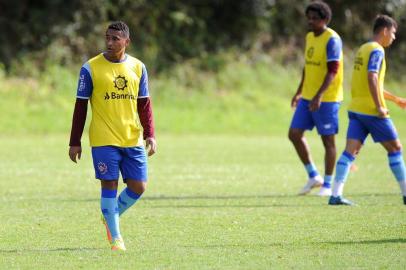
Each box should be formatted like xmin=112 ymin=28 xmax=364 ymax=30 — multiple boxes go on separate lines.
xmin=118 ymin=179 xmax=147 ymax=216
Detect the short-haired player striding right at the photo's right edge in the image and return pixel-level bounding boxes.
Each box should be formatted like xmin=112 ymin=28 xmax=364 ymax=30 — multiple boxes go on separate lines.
xmin=328 ymin=15 xmax=406 ymax=205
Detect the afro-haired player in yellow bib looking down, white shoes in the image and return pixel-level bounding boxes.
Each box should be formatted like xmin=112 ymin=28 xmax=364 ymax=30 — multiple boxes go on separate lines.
xmin=289 ymin=1 xmax=343 ymax=196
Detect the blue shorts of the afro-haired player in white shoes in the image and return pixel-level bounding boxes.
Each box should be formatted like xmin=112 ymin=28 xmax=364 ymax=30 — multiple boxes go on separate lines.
xmin=290 ymin=99 xmax=340 ymax=135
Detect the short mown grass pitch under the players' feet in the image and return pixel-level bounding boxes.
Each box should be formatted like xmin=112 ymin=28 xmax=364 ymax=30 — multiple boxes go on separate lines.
xmin=0 ymin=134 xmax=406 ymax=269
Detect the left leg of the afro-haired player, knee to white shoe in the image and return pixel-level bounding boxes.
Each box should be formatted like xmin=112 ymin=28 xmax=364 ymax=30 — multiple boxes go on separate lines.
xmin=289 ymin=128 xmax=323 ymax=195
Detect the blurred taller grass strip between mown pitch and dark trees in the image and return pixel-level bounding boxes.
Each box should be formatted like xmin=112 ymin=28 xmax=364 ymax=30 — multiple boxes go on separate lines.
xmin=0 ymin=52 xmax=406 ymax=136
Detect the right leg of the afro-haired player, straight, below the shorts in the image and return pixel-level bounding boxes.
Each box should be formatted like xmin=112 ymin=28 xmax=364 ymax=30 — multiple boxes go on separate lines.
xmin=318 ymin=134 xmax=336 ymax=196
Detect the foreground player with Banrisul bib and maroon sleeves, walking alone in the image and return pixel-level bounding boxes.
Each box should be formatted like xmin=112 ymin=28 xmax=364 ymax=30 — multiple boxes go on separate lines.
xmin=69 ymin=22 xmax=156 ymax=250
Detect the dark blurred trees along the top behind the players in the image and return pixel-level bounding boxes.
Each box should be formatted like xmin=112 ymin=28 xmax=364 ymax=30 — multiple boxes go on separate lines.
xmin=0 ymin=0 xmax=406 ymax=73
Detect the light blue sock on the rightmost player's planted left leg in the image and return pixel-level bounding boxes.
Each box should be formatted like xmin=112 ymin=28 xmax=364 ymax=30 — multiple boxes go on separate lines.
xmin=332 ymin=151 xmax=355 ymax=197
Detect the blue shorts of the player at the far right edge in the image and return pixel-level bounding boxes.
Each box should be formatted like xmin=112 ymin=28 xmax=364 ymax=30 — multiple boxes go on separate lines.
xmin=347 ymin=112 xmax=398 ymax=143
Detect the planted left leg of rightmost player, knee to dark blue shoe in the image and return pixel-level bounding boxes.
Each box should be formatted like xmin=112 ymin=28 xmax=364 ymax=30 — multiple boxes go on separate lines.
xmin=329 ymin=139 xmax=362 ymax=205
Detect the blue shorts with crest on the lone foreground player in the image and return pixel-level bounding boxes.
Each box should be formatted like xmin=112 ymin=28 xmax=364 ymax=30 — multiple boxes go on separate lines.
xmin=92 ymin=146 xmax=148 ymax=182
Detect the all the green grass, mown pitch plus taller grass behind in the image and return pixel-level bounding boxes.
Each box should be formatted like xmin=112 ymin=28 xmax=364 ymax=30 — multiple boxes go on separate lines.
xmin=0 ymin=55 xmax=406 ymax=269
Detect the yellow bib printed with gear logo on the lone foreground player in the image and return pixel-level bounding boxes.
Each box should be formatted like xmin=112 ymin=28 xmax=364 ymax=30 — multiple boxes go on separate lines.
xmin=88 ymin=54 xmax=143 ymax=147
